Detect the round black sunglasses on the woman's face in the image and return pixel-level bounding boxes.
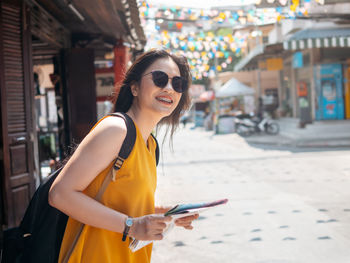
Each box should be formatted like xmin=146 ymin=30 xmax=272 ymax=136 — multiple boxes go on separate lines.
xmin=144 ymin=70 xmax=187 ymax=93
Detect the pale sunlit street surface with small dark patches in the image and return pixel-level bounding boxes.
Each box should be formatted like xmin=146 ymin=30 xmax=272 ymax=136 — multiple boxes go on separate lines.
xmin=152 ymin=127 xmax=350 ymax=263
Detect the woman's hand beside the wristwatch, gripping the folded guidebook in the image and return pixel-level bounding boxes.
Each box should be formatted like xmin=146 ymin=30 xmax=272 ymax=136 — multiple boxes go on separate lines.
xmin=129 ymin=214 xmax=171 ymax=240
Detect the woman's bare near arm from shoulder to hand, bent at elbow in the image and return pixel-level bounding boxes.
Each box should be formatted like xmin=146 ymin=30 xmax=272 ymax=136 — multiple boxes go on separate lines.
xmin=49 ymin=117 xmax=169 ymax=240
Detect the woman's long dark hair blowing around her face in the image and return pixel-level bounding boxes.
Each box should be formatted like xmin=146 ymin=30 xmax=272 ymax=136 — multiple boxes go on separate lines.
xmin=113 ymin=49 xmax=192 ymax=141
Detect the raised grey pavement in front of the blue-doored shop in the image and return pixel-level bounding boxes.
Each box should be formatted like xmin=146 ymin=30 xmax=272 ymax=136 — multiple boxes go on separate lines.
xmin=245 ymin=118 xmax=350 ymax=147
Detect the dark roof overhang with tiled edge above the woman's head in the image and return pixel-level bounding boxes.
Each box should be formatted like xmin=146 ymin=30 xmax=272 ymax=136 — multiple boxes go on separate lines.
xmin=33 ymin=0 xmax=146 ymax=50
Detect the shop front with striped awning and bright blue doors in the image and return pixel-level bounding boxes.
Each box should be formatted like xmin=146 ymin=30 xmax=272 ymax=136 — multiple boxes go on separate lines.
xmin=284 ymin=26 xmax=350 ymax=123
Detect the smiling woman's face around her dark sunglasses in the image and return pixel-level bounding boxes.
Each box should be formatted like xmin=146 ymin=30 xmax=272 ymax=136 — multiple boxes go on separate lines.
xmin=133 ymin=58 xmax=181 ymax=118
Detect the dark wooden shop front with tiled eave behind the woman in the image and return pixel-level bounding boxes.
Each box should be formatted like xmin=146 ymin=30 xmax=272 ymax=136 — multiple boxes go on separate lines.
xmin=0 ymin=0 xmax=145 ymax=229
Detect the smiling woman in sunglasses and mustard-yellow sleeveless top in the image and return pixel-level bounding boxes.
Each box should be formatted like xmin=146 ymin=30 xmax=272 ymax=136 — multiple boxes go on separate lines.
xmin=49 ymin=50 xmax=198 ymax=263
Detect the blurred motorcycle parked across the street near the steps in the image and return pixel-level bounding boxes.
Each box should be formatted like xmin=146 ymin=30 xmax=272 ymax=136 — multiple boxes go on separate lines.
xmin=235 ymin=114 xmax=280 ymax=137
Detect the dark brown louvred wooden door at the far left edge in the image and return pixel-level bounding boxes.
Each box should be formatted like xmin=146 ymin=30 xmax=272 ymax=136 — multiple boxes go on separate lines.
xmin=0 ymin=0 xmax=36 ymax=227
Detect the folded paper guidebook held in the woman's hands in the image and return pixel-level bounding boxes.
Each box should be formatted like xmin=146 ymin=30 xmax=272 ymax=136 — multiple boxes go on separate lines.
xmin=129 ymin=199 xmax=228 ymax=252
